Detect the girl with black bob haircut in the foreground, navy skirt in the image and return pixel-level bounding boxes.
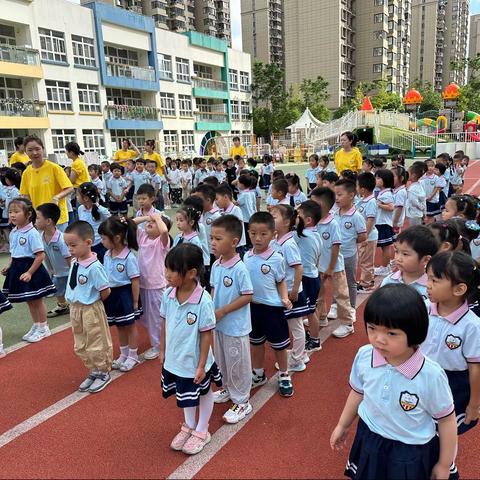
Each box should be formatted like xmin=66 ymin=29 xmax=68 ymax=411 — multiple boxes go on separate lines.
xmin=330 ymin=284 xmax=458 ymax=480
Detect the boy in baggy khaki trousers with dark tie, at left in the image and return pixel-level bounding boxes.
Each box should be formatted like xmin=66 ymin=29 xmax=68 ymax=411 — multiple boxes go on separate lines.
xmin=64 ymin=220 xmax=113 ymax=393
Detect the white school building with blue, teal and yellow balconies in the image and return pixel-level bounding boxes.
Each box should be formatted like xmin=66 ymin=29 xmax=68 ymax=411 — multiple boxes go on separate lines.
xmin=0 ymin=0 xmax=252 ymax=158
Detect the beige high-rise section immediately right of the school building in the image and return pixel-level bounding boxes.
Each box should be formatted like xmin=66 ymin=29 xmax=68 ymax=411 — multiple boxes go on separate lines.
xmin=241 ymin=0 xmax=288 ymax=67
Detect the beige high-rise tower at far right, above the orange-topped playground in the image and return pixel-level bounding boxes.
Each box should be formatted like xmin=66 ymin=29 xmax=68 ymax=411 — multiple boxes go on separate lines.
xmin=410 ymin=0 xmax=469 ymax=90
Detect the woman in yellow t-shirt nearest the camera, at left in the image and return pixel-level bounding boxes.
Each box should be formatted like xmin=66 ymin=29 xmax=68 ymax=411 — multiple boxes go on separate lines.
xmin=20 ymin=135 xmax=73 ymax=231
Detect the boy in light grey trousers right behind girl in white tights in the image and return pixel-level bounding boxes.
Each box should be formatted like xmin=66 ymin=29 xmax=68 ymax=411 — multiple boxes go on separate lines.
xmin=210 ymin=215 xmax=253 ymax=423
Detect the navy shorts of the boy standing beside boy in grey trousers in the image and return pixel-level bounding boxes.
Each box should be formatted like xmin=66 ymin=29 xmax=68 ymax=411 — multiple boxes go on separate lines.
xmin=250 ymin=303 xmax=290 ymax=350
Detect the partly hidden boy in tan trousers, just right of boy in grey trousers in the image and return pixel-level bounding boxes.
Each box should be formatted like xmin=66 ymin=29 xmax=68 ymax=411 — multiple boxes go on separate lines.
xmin=357 ymin=172 xmax=378 ymax=293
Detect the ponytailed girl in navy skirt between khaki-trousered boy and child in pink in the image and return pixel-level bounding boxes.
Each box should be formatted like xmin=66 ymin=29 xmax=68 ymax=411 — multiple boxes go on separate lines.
xmin=98 ymin=216 xmax=142 ymax=372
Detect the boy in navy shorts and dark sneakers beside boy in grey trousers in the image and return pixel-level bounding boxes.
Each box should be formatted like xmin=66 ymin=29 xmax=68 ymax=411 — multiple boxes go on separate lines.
xmin=244 ymin=212 xmax=293 ymax=397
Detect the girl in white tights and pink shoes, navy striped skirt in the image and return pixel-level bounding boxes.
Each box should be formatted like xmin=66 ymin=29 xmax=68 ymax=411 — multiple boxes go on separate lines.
xmin=159 ymin=243 xmax=222 ymax=455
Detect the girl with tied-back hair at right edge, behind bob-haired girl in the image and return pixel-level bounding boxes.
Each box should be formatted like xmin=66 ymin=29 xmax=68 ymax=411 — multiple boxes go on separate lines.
xmin=422 ymin=252 xmax=480 ymax=434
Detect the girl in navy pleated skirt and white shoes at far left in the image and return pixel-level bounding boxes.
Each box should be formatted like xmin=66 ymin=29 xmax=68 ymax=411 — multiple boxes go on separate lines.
xmin=0 ymin=197 xmax=55 ymax=343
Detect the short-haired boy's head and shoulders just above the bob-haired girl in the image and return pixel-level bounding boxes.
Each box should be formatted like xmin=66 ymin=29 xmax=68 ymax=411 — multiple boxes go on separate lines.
xmin=382 ymin=225 xmax=439 ymax=300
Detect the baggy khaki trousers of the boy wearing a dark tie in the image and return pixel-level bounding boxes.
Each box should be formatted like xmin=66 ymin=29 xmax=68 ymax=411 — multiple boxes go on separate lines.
xmin=70 ymin=300 xmax=113 ymax=372
